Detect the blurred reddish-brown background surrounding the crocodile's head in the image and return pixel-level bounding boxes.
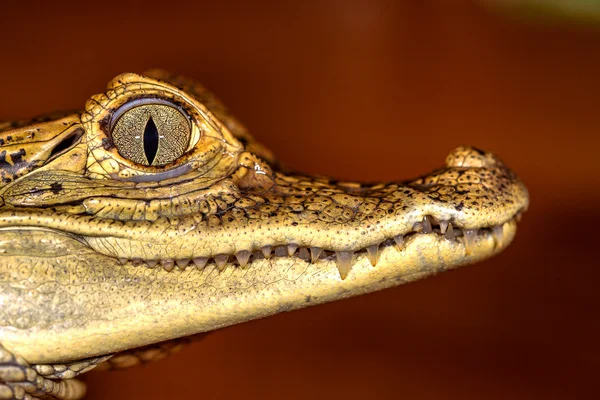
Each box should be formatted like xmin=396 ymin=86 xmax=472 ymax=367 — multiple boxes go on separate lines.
xmin=0 ymin=0 xmax=600 ymax=399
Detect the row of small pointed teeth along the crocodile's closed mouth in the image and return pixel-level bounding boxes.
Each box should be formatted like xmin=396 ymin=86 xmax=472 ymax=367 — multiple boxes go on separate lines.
xmin=119 ymin=215 xmax=520 ymax=279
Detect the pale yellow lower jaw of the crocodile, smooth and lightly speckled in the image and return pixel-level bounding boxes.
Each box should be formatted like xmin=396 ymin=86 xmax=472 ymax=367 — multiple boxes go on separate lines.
xmin=0 ymin=220 xmax=516 ymax=363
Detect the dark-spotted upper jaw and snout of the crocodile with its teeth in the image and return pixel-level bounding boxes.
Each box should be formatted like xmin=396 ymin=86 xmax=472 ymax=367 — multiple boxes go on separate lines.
xmin=0 ymin=147 xmax=528 ymax=277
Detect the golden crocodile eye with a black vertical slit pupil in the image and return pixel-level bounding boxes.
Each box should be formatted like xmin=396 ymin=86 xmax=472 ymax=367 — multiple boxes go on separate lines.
xmin=112 ymin=103 xmax=191 ymax=166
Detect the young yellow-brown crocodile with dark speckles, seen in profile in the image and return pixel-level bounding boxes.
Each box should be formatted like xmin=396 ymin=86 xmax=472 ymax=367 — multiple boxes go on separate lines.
xmin=0 ymin=70 xmax=529 ymax=399
